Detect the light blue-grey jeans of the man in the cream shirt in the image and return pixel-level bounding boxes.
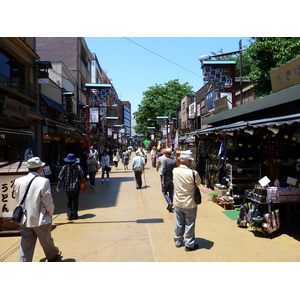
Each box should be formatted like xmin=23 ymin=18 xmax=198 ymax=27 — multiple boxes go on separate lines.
xmin=174 ymin=206 xmax=197 ymax=248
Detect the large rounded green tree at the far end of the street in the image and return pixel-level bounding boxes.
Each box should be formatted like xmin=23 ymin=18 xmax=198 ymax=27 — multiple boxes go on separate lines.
xmin=133 ymin=79 xmax=195 ymax=137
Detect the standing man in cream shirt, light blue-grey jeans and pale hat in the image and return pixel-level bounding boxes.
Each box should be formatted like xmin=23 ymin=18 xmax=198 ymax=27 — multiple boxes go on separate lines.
xmin=173 ymin=151 xmax=201 ymax=251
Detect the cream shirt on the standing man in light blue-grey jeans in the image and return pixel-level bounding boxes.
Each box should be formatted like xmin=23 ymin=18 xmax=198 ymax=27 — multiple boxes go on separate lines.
xmin=173 ymin=165 xmax=201 ymax=209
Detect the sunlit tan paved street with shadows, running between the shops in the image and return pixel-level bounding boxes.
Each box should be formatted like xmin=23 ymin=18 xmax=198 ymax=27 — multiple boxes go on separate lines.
xmin=0 ymin=160 xmax=300 ymax=262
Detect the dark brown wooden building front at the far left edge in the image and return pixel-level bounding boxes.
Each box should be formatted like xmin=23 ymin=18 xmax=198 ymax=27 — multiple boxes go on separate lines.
xmin=0 ymin=37 xmax=42 ymax=161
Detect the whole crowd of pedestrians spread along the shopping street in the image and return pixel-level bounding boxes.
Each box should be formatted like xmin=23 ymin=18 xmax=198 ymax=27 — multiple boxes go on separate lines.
xmin=14 ymin=146 xmax=201 ymax=261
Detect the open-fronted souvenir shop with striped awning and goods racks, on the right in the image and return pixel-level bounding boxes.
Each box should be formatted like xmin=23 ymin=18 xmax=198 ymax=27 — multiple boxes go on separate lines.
xmin=193 ymin=85 xmax=300 ymax=233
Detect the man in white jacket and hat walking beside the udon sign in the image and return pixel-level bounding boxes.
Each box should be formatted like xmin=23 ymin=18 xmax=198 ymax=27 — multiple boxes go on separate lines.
xmin=14 ymin=157 xmax=61 ymax=262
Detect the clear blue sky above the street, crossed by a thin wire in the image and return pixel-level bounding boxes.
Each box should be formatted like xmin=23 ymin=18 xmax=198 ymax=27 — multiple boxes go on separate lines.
xmin=85 ymin=37 xmax=249 ymax=112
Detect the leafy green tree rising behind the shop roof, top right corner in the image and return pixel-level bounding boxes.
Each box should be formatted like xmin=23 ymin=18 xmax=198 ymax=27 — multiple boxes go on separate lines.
xmin=245 ymin=37 xmax=300 ymax=96
